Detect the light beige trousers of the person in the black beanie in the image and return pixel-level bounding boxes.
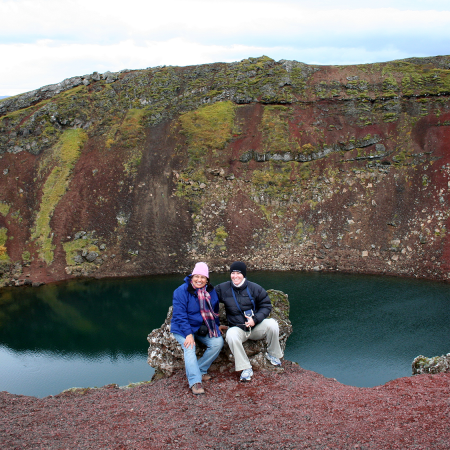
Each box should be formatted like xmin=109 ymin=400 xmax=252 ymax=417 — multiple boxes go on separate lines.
xmin=225 ymin=319 xmax=283 ymax=370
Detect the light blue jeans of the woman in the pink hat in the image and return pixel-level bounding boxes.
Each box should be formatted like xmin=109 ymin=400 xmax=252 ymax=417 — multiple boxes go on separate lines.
xmin=172 ymin=333 xmax=223 ymax=387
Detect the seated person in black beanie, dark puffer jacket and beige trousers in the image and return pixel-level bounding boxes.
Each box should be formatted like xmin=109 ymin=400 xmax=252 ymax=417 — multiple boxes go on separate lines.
xmin=216 ymin=261 xmax=283 ymax=381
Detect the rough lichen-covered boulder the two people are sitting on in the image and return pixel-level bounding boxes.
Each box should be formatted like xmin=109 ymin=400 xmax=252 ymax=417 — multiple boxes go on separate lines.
xmin=147 ymin=289 xmax=292 ymax=376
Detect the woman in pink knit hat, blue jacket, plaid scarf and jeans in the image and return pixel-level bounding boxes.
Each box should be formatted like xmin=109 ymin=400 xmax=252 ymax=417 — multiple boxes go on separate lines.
xmin=170 ymin=262 xmax=223 ymax=395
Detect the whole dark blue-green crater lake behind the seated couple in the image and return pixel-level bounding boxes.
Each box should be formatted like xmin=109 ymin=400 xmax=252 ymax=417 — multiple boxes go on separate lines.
xmin=0 ymin=272 xmax=450 ymax=397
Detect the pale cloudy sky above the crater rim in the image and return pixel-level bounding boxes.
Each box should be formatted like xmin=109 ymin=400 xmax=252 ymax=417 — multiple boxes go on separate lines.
xmin=0 ymin=0 xmax=450 ymax=97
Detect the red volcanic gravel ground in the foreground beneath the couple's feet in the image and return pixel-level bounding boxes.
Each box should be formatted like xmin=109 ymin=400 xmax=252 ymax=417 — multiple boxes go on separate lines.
xmin=0 ymin=361 xmax=450 ymax=450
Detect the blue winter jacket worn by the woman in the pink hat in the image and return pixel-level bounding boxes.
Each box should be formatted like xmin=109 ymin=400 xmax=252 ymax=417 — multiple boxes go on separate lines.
xmin=170 ymin=276 xmax=220 ymax=337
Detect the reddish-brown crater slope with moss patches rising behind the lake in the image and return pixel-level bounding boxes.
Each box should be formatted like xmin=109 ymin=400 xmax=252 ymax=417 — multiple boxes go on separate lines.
xmin=0 ymin=56 xmax=450 ymax=285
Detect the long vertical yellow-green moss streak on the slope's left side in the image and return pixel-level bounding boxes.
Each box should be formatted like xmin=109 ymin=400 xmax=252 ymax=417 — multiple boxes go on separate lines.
xmin=31 ymin=129 xmax=87 ymax=264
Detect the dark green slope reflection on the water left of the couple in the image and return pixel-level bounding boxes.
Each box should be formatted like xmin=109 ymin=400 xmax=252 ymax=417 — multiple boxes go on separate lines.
xmin=0 ymin=277 xmax=179 ymax=357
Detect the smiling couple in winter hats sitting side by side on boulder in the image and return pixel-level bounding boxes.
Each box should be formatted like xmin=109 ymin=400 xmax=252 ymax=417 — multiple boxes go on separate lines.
xmin=170 ymin=261 xmax=283 ymax=394
